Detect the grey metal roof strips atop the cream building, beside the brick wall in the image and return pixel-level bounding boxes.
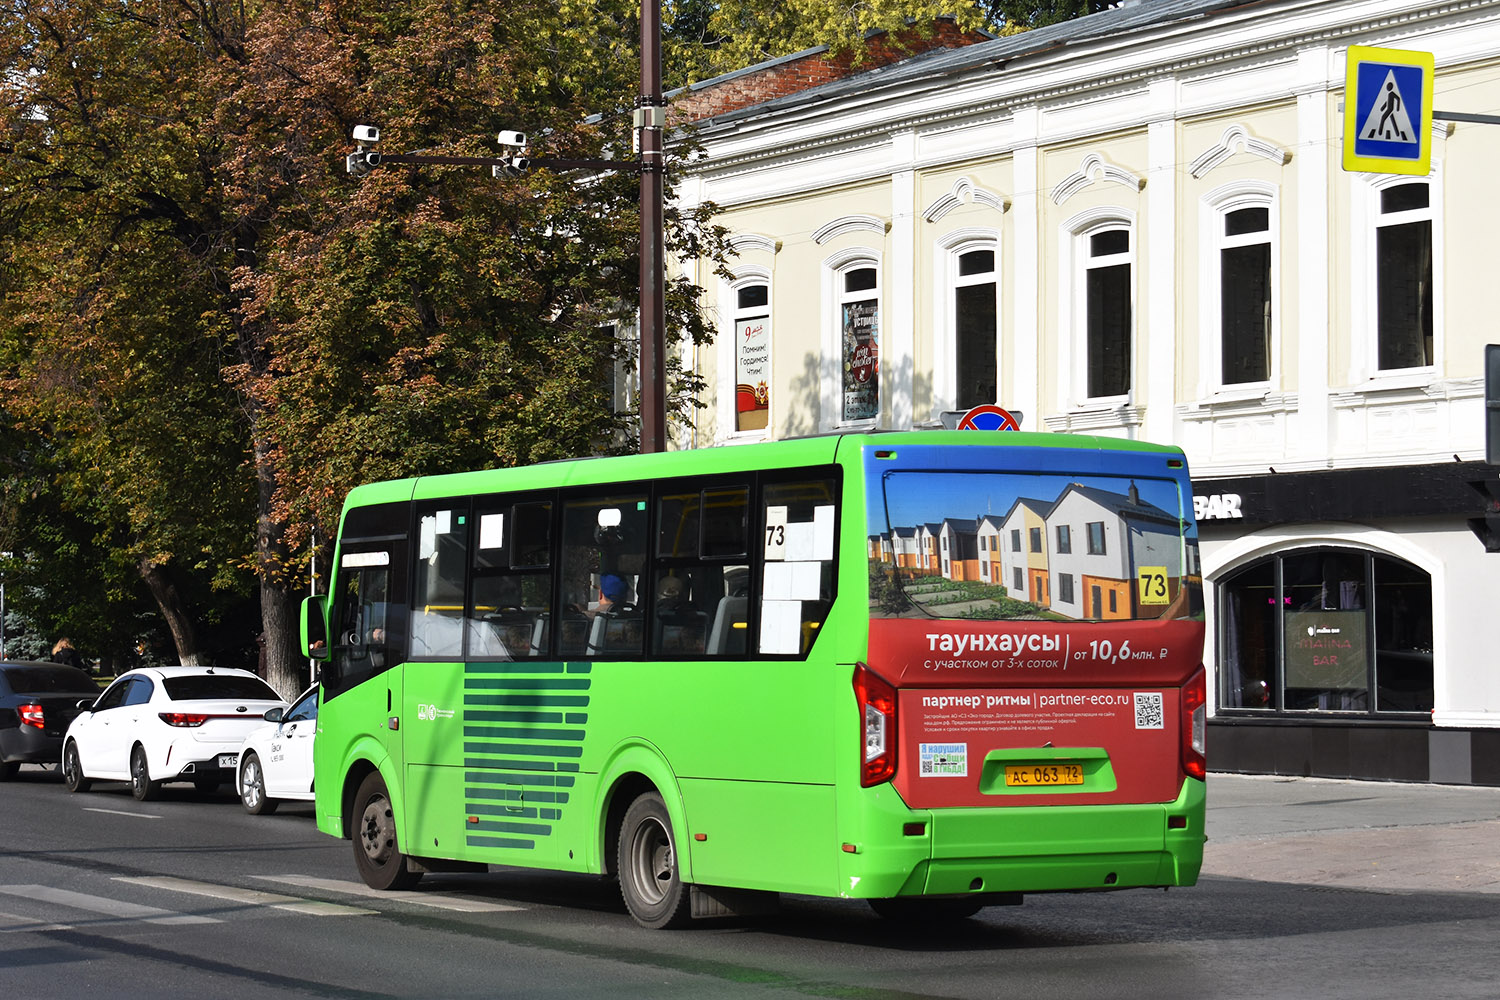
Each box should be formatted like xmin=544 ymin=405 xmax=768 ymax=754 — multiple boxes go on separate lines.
xmin=695 ymin=0 xmax=1265 ymax=123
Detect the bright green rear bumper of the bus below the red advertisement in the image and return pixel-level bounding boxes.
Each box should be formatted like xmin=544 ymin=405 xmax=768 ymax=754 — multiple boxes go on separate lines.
xmin=849 ymin=778 xmax=1205 ymax=898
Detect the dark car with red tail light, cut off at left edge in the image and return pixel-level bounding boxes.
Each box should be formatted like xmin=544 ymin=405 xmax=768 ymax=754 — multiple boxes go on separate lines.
xmin=0 ymin=660 xmax=99 ymax=781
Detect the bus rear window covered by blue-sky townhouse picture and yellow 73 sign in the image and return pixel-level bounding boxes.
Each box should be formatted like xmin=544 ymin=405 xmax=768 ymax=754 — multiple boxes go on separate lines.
xmin=869 ymin=469 xmax=1202 ymax=621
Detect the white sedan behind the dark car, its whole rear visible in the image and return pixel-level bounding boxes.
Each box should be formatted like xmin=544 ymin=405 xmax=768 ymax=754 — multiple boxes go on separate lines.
xmin=63 ymin=667 xmax=287 ymax=802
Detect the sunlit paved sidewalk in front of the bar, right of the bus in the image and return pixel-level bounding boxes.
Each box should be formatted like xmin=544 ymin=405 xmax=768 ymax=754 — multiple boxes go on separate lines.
xmin=1203 ymin=774 xmax=1500 ymax=894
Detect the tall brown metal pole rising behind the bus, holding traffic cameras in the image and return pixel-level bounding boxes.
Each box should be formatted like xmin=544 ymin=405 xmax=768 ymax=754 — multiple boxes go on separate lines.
xmin=636 ymin=0 xmax=666 ymax=454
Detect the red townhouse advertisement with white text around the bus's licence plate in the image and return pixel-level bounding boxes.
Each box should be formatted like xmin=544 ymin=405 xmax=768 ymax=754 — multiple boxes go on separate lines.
xmin=869 ymin=619 xmax=1203 ymax=808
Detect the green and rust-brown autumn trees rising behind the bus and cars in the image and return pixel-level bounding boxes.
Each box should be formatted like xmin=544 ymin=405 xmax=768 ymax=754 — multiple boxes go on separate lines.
xmin=0 ymin=0 xmax=1062 ymax=694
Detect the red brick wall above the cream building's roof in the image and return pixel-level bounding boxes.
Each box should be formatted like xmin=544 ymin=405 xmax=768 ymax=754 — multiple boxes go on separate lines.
xmin=671 ymin=18 xmax=989 ymax=121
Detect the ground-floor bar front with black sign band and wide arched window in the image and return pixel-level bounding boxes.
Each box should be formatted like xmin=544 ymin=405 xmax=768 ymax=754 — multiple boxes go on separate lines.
xmin=1194 ymin=462 xmax=1500 ymax=784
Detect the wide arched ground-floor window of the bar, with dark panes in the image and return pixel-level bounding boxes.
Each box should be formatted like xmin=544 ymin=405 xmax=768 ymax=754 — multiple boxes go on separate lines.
xmin=1218 ymin=547 xmax=1433 ymax=715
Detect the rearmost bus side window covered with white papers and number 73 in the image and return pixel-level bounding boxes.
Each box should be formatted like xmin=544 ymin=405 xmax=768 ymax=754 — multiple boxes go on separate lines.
xmin=758 ymin=478 xmax=839 ymax=655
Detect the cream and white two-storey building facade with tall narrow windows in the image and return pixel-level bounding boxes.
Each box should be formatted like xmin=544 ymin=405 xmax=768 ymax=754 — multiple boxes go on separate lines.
xmin=675 ymin=0 xmax=1500 ymax=784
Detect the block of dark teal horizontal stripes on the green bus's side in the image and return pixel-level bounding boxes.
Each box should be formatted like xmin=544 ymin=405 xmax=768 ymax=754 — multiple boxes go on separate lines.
xmin=464 ymin=661 xmax=593 ymax=850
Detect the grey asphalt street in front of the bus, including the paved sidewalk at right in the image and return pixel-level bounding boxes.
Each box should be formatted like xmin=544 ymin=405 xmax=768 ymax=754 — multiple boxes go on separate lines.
xmin=0 ymin=769 xmax=1500 ymax=1000
